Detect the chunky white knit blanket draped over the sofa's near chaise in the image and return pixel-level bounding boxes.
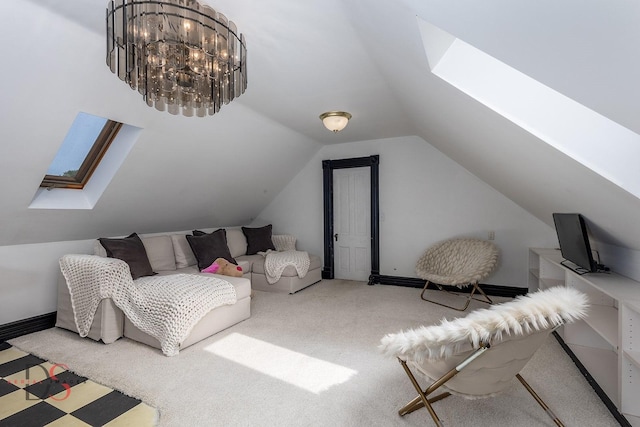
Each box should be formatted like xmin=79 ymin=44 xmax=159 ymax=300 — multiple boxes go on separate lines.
xmin=60 ymin=255 xmax=236 ymax=356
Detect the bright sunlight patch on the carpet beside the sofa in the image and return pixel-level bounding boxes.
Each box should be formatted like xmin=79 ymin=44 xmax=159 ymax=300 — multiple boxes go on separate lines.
xmin=204 ymin=333 xmax=358 ymax=394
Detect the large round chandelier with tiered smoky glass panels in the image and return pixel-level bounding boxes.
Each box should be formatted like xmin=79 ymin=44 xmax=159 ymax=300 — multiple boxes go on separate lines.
xmin=107 ymin=0 xmax=247 ymax=117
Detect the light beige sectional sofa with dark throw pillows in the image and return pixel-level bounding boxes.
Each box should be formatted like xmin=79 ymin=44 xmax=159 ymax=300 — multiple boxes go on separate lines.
xmin=56 ymin=227 xmax=322 ymax=349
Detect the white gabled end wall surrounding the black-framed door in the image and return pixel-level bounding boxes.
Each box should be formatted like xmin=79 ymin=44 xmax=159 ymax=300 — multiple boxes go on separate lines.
xmin=258 ymin=137 xmax=557 ymax=287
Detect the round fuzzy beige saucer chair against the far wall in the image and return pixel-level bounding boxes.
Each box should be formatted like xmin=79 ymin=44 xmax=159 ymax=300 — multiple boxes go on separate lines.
xmin=416 ymin=239 xmax=499 ymax=311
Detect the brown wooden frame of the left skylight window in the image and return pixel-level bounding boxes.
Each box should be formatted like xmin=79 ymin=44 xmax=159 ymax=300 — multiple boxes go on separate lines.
xmin=40 ymin=119 xmax=122 ymax=190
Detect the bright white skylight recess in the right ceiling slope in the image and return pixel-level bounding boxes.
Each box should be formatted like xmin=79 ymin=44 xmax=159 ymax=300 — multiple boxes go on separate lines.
xmin=418 ymin=18 xmax=640 ymax=201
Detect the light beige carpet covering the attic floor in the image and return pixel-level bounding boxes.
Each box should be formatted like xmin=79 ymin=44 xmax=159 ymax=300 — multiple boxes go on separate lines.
xmin=10 ymin=280 xmax=618 ymax=427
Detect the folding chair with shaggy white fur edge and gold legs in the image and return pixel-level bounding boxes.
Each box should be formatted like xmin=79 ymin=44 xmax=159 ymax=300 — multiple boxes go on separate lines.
xmin=380 ymin=286 xmax=588 ymax=426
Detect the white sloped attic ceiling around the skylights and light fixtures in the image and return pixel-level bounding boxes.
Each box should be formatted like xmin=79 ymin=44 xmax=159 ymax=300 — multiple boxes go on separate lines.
xmin=0 ymin=0 xmax=640 ymax=250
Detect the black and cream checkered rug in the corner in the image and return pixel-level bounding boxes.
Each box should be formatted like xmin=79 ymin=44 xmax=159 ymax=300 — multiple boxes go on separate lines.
xmin=0 ymin=342 xmax=157 ymax=427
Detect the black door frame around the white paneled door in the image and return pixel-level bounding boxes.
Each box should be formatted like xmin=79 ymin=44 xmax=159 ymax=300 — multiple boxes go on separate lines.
xmin=322 ymin=154 xmax=380 ymax=285
